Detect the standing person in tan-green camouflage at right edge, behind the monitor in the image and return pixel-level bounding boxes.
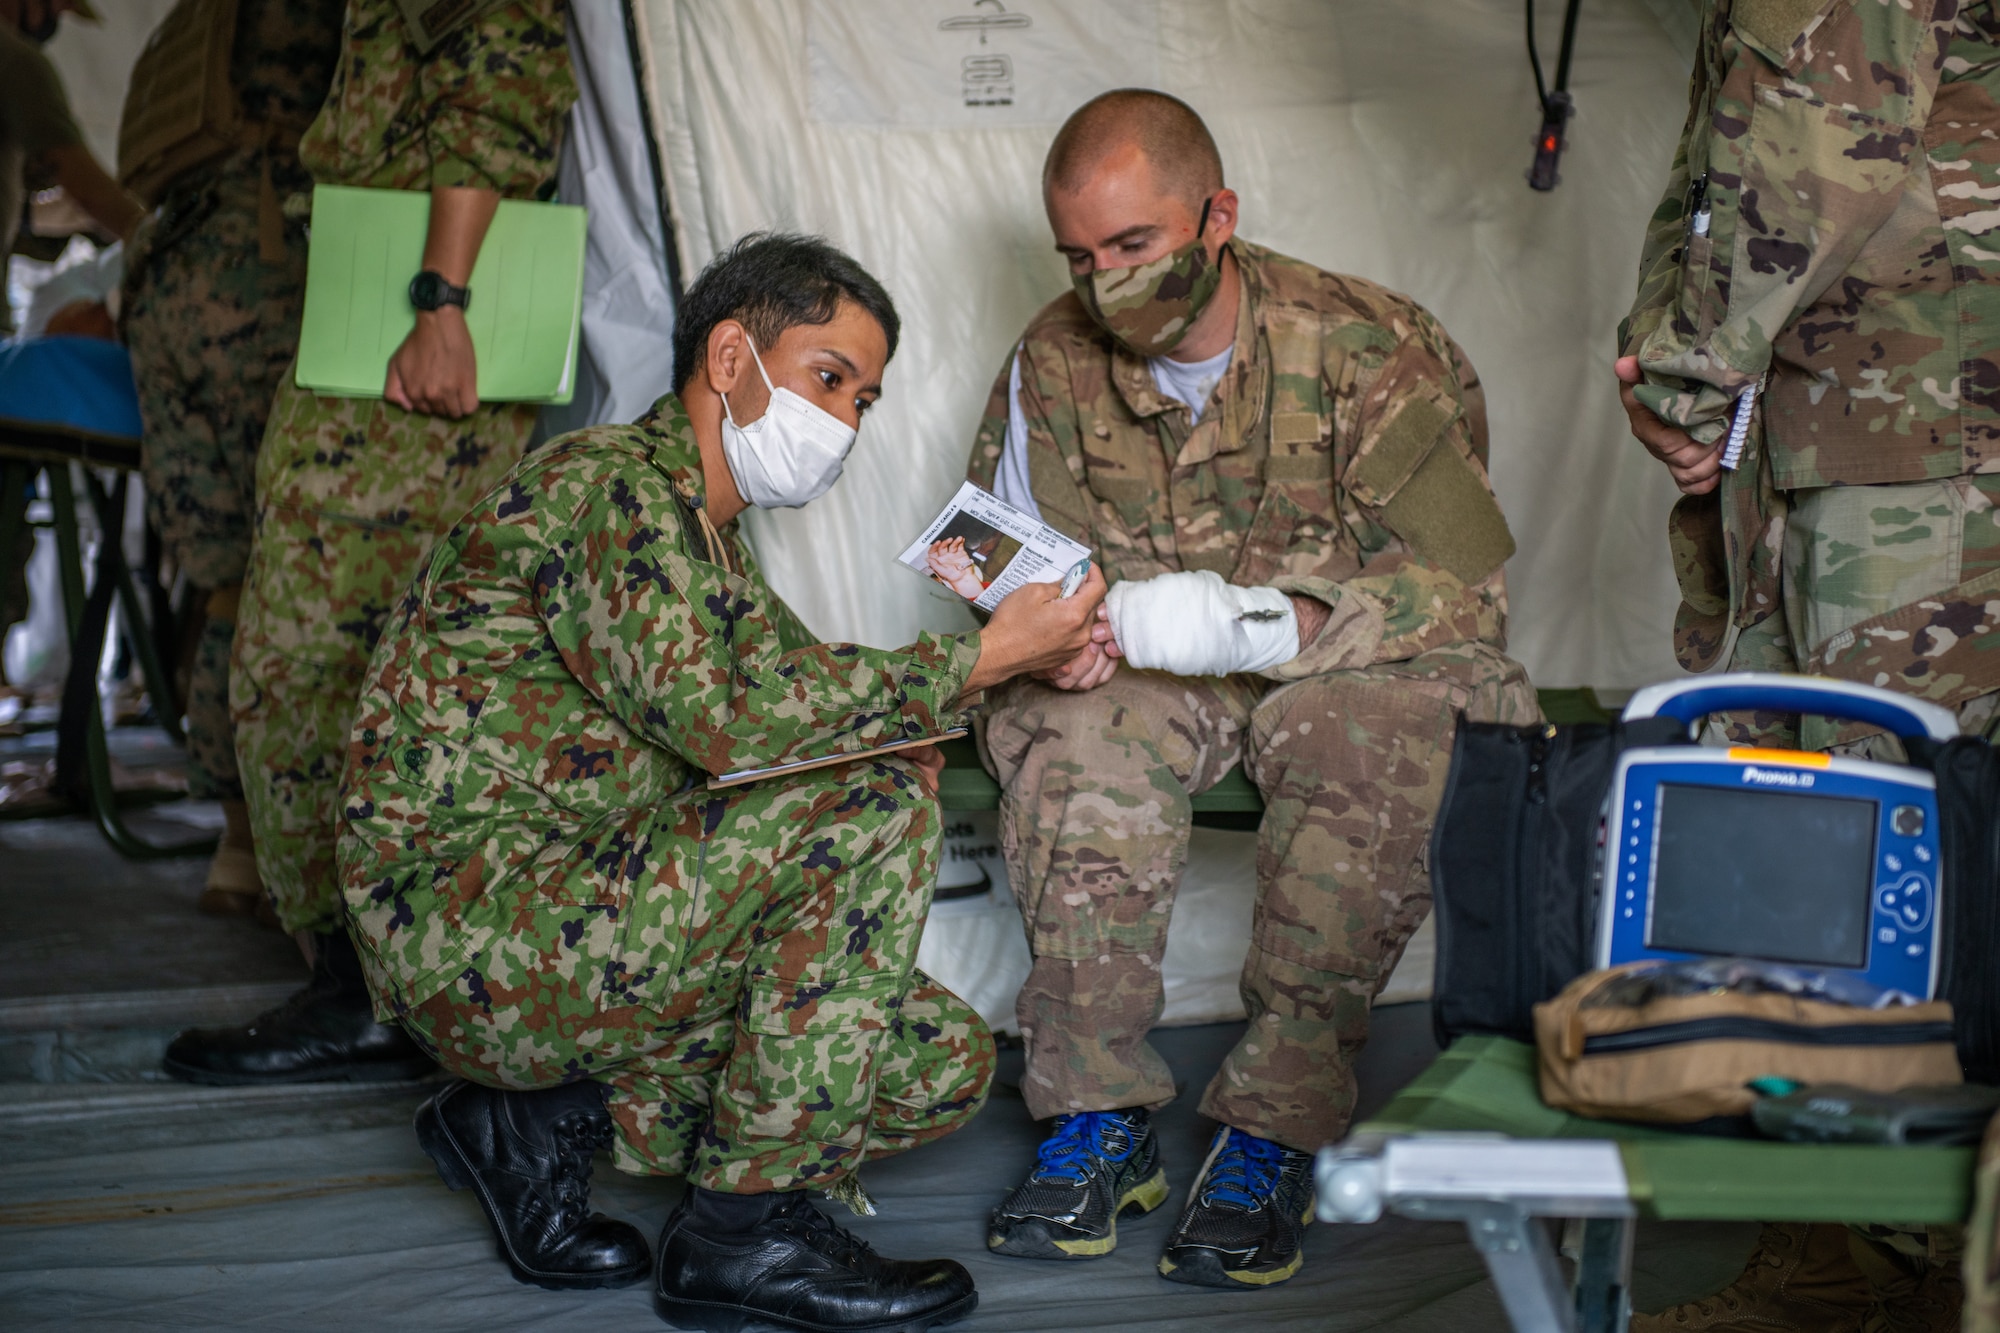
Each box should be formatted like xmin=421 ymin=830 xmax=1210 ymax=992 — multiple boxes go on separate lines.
xmin=1618 ymin=0 xmax=2000 ymax=1333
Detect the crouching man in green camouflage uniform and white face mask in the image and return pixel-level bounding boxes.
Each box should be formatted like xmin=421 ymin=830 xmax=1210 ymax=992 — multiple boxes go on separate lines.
xmin=340 ymin=236 xmax=1104 ymax=1331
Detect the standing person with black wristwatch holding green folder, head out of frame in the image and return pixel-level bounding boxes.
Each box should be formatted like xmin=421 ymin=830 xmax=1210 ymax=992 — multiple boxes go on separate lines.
xmin=166 ymin=0 xmax=576 ymax=1083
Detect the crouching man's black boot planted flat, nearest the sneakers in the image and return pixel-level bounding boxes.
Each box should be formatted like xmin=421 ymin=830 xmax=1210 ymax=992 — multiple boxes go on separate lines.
xmin=654 ymin=1185 xmax=980 ymax=1333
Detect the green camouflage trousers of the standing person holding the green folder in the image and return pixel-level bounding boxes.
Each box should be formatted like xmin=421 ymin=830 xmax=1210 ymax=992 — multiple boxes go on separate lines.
xmin=230 ymin=372 xmax=536 ymax=931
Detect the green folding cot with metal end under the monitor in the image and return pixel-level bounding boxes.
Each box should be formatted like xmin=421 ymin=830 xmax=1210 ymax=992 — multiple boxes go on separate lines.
xmin=1316 ymin=1037 xmax=1976 ymax=1333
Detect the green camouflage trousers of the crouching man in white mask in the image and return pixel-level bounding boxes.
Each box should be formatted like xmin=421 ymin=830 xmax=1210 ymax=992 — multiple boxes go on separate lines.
xmin=354 ymin=761 xmax=994 ymax=1193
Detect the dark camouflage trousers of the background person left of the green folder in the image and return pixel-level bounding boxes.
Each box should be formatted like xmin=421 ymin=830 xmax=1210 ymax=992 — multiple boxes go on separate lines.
xmin=124 ymin=182 xmax=306 ymax=801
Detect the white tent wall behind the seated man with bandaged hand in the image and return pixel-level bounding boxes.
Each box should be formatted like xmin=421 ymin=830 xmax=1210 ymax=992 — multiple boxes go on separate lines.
xmin=636 ymin=0 xmax=1688 ymax=687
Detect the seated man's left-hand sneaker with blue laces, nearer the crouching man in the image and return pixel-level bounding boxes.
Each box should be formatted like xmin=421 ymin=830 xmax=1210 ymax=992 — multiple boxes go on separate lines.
xmin=986 ymin=1111 xmax=1166 ymax=1259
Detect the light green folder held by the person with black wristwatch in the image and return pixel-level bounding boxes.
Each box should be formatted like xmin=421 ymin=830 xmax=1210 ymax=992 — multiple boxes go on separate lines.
xmin=294 ymin=186 xmax=588 ymax=402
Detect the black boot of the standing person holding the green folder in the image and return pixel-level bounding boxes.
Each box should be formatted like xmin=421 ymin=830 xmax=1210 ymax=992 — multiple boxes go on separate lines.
xmin=160 ymin=931 xmax=436 ymax=1087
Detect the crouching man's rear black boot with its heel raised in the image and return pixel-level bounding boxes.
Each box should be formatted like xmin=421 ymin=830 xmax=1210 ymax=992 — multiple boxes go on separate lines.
xmin=416 ymin=1083 xmax=652 ymax=1291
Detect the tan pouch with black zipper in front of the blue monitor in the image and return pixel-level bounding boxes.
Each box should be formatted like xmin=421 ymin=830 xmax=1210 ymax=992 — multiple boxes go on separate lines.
xmin=1534 ymin=963 xmax=1964 ymax=1125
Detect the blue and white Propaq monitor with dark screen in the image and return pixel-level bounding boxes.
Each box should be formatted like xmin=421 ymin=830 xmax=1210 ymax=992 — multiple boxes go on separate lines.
xmin=1596 ymin=747 xmax=1940 ymax=999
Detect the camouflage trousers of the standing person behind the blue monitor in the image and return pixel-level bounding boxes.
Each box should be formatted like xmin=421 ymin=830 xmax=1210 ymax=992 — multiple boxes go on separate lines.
xmin=1726 ymin=476 xmax=2000 ymax=755
